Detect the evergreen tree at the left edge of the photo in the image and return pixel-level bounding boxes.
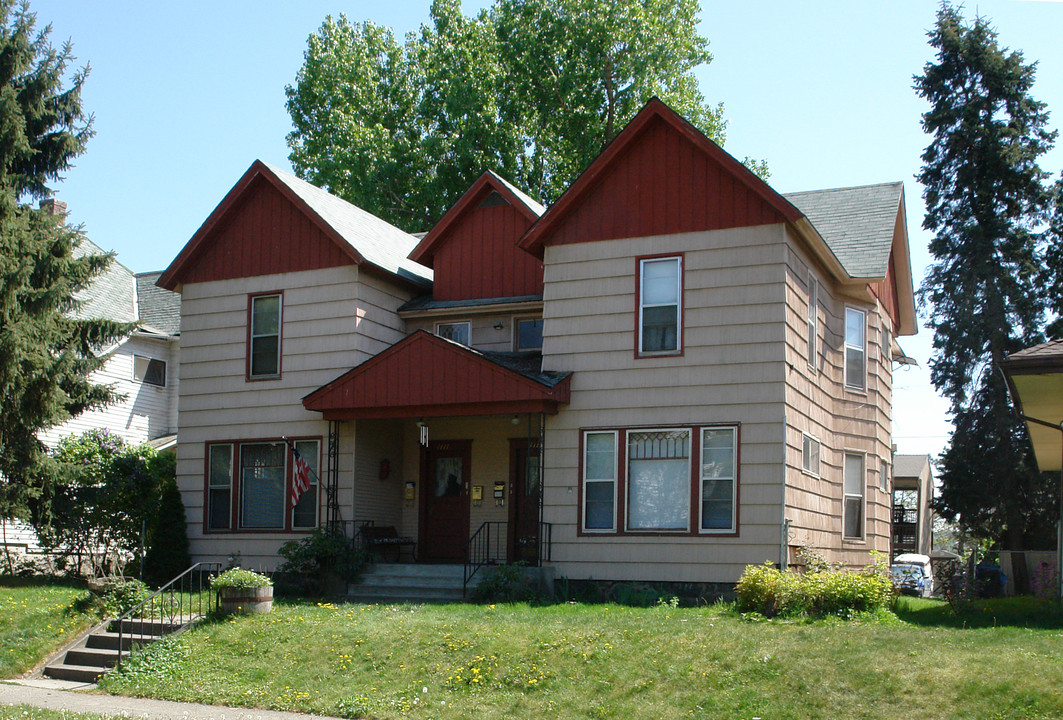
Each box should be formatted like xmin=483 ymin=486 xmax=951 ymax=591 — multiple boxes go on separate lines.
xmin=0 ymin=0 xmax=131 ymax=525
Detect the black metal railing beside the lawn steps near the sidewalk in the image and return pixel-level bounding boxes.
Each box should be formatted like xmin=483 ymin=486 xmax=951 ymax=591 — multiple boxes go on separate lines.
xmin=113 ymin=563 xmax=221 ymax=666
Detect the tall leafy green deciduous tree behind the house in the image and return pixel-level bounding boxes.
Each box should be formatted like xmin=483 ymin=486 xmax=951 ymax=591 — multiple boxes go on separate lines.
xmin=287 ymin=0 xmax=748 ymax=231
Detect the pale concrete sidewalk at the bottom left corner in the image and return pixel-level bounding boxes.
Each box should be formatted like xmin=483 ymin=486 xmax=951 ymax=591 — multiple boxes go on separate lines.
xmin=0 ymin=680 xmax=342 ymax=720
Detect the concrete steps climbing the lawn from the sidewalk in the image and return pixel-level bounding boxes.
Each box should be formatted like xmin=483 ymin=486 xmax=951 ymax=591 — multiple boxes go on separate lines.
xmin=43 ymin=617 xmax=192 ymax=683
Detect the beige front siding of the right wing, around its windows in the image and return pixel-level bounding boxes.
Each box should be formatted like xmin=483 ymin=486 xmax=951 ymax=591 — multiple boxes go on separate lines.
xmin=543 ymin=224 xmax=787 ymax=583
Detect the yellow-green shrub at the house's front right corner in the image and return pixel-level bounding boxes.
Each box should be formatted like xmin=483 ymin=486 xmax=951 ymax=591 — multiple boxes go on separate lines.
xmin=735 ymin=562 xmax=894 ymax=617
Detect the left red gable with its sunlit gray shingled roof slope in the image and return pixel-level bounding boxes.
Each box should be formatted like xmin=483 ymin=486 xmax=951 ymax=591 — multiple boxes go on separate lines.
xmin=157 ymin=161 xmax=431 ymax=290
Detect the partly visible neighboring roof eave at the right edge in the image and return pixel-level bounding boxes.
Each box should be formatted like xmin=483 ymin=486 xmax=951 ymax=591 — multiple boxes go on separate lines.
xmin=1000 ymin=340 xmax=1063 ymax=472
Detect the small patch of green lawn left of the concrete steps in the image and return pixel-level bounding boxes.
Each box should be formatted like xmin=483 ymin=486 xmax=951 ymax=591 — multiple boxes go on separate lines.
xmin=0 ymin=577 xmax=98 ymax=677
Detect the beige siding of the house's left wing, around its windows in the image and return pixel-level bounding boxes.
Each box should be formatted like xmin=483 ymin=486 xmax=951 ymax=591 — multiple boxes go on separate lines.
xmin=178 ymin=266 xmax=411 ymax=569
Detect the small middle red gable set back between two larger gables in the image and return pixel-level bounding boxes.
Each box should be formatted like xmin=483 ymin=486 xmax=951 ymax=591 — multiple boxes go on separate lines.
xmin=409 ymin=171 xmax=545 ymax=300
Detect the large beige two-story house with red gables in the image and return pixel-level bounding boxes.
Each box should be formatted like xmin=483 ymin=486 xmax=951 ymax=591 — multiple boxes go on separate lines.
xmin=158 ymin=100 xmax=915 ymax=587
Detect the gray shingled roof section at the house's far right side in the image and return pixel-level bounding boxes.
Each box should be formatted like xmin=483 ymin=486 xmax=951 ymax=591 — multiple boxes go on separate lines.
xmin=783 ymin=182 xmax=904 ymax=278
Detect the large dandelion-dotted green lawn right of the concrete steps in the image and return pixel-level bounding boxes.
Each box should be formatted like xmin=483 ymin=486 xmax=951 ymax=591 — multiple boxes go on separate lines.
xmin=93 ymin=601 xmax=1063 ymax=720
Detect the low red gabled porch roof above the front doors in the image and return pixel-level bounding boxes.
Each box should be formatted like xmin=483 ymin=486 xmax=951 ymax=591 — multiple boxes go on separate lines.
xmin=303 ymin=330 xmax=571 ymax=420
